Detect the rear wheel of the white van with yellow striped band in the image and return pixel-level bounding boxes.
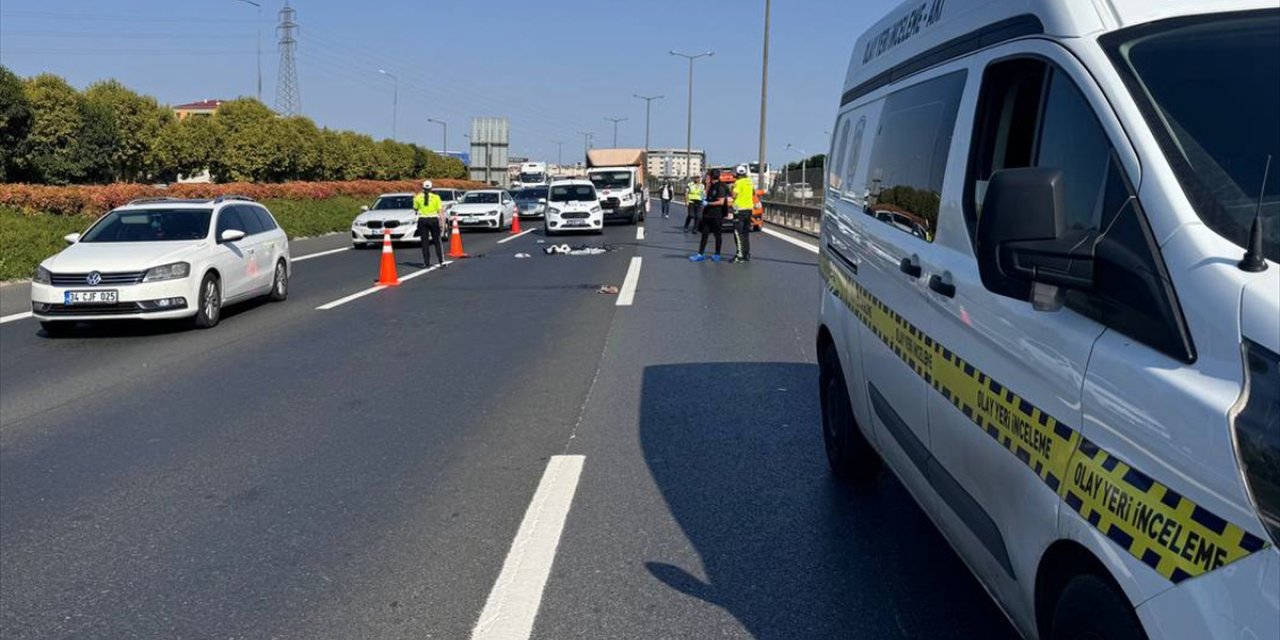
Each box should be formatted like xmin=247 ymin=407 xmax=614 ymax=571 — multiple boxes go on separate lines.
xmin=818 ymin=347 xmax=881 ymax=480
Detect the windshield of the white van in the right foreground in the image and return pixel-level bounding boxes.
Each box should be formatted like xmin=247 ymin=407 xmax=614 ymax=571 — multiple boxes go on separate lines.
xmin=1103 ymin=10 xmax=1280 ymax=260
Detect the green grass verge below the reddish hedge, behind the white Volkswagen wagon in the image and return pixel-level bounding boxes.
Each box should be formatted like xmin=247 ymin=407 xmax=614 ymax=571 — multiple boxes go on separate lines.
xmin=0 ymin=196 xmax=372 ymax=282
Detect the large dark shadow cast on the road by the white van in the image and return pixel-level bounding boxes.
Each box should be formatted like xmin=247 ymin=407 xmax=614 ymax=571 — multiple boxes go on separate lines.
xmin=640 ymin=362 xmax=1016 ymax=639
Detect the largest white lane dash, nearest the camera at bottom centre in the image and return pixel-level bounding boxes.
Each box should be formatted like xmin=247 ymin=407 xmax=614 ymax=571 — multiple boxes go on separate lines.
xmin=471 ymin=456 xmax=585 ymax=640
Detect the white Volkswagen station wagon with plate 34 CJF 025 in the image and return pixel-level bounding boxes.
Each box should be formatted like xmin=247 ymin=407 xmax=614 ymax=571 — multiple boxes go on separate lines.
xmin=31 ymin=196 xmax=292 ymax=335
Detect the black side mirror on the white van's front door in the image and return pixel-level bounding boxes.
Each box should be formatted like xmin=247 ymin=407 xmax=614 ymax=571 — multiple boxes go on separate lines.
xmin=974 ymin=168 xmax=1094 ymax=311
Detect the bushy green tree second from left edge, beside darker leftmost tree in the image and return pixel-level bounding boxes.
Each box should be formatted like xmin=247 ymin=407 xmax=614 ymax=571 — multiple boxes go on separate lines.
xmin=15 ymin=73 xmax=84 ymax=184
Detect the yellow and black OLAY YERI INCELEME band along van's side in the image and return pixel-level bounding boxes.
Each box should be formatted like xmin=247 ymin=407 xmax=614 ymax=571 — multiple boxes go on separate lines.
xmin=818 ymin=252 xmax=1267 ymax=582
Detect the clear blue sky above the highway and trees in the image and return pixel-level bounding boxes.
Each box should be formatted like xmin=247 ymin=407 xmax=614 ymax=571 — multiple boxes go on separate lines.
xmin=0 ymin=0 xmax=897 ymax=165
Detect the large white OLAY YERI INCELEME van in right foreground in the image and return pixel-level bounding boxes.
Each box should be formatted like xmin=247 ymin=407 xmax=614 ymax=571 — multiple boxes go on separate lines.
xmin=817 ymin=0 xmax=1280 ymax=639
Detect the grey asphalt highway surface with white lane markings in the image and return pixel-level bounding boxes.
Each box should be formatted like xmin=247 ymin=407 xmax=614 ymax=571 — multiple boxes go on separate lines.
xmin=0 ymin=206 xmax=1014 ymax=639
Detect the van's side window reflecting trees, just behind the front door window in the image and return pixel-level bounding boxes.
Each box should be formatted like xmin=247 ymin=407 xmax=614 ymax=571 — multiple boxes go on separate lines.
xmin=864 ymin=70 xmax=965 ymax=242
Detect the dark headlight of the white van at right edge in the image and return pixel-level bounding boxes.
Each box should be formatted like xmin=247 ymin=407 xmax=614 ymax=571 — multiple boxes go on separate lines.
xmin=1234 ymin=339 xmax=1280 ymax=544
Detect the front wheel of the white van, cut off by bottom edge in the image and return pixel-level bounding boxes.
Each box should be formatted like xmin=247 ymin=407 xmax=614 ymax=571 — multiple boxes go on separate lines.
xmin=1048 ymin=573 xmax=1147 ymax=640
